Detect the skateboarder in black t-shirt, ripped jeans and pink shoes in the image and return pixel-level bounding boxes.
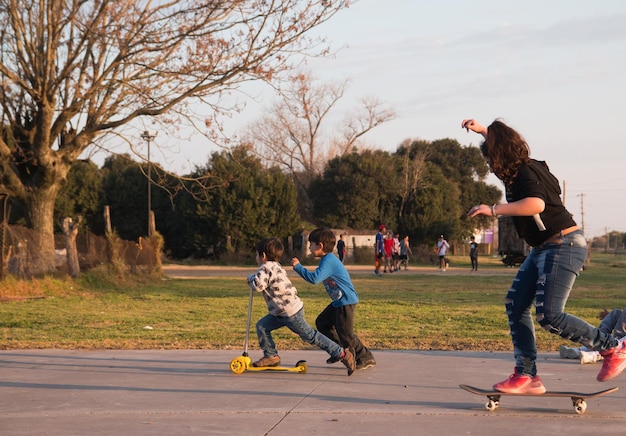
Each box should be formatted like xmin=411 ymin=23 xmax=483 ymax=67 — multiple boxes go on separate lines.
xmin=461 ymin=119 xmax=626 ymax=394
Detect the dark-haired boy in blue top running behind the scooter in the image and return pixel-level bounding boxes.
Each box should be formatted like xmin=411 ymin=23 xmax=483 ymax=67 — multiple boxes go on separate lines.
xmin=291 ymin=228 xmax=376 ymax=369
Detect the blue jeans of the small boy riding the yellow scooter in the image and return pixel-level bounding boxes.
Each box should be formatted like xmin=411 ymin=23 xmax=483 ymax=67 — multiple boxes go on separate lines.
xmin=256 ymin=308 xmax=343 ymax=359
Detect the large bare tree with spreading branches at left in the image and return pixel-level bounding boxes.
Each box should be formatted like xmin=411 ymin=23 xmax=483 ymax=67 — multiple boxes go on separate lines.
xmin=0 ymin=0 xmax=348 ymax=274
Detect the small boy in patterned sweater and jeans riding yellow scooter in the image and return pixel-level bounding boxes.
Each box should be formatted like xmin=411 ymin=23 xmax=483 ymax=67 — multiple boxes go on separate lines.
xmin=248 ymin=238 xmax=356 ymax=375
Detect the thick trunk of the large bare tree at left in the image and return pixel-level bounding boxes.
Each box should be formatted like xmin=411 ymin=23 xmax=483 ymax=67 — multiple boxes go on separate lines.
xmin=24 ymin=186 xmax=57 ymax=277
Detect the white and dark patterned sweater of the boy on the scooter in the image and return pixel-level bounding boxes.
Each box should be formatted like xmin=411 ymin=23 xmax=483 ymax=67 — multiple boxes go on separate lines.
xmin=248 ymin=261 xmax=304 ymax=316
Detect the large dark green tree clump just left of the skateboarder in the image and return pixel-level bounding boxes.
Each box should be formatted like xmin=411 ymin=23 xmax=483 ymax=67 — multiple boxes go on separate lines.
xmin=309 ymin=139 xmax=501 ymax=245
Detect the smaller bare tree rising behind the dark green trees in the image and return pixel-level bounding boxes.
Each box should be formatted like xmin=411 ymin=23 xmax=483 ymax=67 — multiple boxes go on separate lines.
xmin=247 ymin=73 xmax=395 ymax=188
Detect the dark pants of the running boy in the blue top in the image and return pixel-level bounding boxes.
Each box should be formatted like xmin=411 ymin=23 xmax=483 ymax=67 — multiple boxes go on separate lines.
xmin=315 ymin=304 xmax=374 ymax=363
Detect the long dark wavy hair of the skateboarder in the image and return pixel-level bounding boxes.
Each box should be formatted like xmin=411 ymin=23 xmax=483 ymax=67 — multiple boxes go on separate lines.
xmin=480 ymin=120 xmax=530 ymax=186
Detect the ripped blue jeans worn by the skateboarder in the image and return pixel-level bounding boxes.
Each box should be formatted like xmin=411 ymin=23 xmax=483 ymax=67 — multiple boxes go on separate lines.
xmin=505 ymin=230 xmax=617 ymax=377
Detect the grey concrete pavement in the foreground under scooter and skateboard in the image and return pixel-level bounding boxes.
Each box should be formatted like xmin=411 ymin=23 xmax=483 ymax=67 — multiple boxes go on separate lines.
xmin=0 ymin=350 xmax=626 ymax=436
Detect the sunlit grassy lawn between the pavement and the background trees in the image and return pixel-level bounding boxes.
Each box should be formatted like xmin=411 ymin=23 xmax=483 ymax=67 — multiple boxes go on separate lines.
xmin=0 ymin=255 xmax=626 ymax=351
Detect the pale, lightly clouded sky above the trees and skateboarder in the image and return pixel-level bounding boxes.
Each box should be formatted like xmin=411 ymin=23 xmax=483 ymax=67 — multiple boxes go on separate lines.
xmin=129 ymin=0 xmax=626 ymax=238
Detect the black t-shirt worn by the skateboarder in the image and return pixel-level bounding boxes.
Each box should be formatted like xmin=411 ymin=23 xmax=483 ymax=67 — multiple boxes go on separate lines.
xmin=506 ymin=159 xmax=576 ymax=247
